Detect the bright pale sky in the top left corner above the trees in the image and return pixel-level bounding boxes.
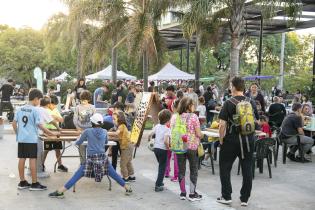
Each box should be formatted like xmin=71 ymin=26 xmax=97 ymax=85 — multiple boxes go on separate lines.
xmin=0 ymin=0 xmax=67 ymax=30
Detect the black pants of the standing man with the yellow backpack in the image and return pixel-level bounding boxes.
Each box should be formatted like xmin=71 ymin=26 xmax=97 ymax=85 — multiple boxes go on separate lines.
xmin=219 ymin=137 xmax=254 ymax=202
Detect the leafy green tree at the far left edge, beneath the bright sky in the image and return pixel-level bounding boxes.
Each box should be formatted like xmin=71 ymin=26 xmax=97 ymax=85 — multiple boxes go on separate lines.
xmin=0 ymin=27 xmax=45 ymax=87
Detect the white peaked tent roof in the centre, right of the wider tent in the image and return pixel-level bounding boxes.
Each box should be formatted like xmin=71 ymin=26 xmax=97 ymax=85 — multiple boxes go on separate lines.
xmin=149 ymin=63 xmax=195 ymax=80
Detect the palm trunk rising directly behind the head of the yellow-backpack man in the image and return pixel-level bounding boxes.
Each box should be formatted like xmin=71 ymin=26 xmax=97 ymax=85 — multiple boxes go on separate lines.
xmin=230 ymin=34 xmax=240 ymax=78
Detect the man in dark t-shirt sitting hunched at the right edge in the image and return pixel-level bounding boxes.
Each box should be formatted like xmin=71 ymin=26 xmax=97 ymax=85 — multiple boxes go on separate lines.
xmin=281 ymin=103 xmax=314 ymax=162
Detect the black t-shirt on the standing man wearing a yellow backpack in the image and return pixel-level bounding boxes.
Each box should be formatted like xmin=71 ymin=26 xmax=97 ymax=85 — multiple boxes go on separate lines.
xmin=219 ymin=96 xmax=259 ymax=136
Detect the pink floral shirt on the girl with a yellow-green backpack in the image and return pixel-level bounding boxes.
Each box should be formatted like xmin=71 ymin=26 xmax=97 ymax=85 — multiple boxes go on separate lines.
xmin=171 ymin=113 xmax=200 ymax=150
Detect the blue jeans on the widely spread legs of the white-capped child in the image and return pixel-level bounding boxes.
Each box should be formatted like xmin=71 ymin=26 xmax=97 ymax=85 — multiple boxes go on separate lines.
xmin=64 ymin=164 xmax=125 ymax=190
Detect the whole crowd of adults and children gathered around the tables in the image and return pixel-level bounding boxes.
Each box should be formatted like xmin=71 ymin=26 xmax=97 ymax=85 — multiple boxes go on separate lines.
xmin=0 ymin=77 xmax=314 ymax=206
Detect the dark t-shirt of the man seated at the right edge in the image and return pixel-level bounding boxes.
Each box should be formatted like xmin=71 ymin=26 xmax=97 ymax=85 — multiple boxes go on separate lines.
xmin=281 ymin=113 xmax=303 ymax=137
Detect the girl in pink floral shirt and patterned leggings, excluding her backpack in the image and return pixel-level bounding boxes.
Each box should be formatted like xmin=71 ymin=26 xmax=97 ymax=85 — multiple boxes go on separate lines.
xmin=171 ymin=97 xmax=203 ymax=201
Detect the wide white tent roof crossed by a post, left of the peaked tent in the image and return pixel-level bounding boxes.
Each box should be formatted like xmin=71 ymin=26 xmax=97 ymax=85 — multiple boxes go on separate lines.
xmin=85 ymin=65 xmax=136 ymax=80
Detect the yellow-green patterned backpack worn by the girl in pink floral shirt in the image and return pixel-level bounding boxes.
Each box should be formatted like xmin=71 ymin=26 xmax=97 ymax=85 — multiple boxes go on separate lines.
xmin=170 ymin=113 xmax=187 ymax=154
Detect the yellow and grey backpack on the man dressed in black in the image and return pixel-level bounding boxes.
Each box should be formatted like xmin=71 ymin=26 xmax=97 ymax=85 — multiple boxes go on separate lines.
xmin=229 ymin=98 xmax=255 ymax=136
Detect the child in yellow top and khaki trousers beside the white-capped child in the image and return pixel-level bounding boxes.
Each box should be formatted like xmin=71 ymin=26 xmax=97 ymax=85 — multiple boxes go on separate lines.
xmin=108 ymin=111 xmax=136 ymax=182
